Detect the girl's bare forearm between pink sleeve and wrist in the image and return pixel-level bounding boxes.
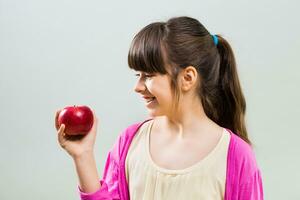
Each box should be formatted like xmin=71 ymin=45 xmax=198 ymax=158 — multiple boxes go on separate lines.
xmin=73 ymin=153 xmax=101 ymax=193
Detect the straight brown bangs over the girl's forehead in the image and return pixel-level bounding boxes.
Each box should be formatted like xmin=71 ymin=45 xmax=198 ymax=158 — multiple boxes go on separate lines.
xmin=128 ymin=22 xmax=167 ymax=74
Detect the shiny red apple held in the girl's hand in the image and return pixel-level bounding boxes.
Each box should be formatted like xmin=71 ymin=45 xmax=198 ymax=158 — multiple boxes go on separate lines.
xmin=57 ymin=105 xmax=94 ymax=135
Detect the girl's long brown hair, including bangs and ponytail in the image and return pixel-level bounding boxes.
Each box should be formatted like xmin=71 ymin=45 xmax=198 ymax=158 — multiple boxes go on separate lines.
xmin=128 ymin=16 xmax=251 ymax=144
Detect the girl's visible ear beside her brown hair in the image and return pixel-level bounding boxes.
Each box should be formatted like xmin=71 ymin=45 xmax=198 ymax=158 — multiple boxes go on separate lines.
xmin=180 ymin=66 xmax=198 ymax=92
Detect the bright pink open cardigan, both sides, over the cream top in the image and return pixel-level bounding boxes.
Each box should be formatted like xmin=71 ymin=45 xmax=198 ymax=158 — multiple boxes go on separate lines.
xmin=78 ymin=119 xmax=263 ymax=200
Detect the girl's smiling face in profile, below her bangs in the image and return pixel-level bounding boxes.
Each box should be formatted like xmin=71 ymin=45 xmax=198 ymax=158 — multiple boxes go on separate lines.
xmin=134 ymin=72 xmax=172 ymax=117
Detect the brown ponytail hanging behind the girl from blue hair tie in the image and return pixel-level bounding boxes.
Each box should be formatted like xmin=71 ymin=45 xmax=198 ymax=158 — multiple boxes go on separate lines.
xmin=216 ymin=35 xmax=251 ymax=145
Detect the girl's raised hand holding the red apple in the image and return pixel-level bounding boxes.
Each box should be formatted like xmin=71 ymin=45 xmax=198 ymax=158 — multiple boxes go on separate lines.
xmin=55 ymin=110 xmax=98 ymax=158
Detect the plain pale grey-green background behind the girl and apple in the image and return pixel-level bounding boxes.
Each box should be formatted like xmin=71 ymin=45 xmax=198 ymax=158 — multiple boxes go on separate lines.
xmin=0 ymin=0 xmax=300 ymax=200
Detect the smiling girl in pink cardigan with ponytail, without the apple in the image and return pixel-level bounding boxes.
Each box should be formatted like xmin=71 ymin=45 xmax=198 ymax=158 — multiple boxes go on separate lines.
xmin=56 ymin=17 xmax=263 ymax=200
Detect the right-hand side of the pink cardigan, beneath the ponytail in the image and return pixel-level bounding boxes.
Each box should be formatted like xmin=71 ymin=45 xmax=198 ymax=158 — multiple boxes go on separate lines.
xmin=225 ymin=131 xmax=263 ymax=199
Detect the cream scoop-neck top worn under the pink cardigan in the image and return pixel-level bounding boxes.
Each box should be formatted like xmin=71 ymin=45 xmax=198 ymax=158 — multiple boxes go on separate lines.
xmin=125 ymin=120 xmax=230 ymax=200
